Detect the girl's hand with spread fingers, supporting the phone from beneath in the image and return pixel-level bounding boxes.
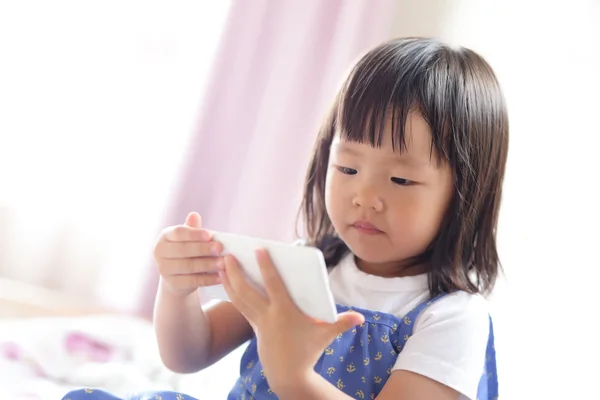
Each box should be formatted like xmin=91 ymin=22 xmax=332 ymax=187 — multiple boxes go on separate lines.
xmin=220 ymin=250 xmax=364 ymax=393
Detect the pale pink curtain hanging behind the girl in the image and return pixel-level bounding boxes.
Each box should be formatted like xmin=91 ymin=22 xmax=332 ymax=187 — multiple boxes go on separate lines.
xmin=140 ymin=0 xmax=406 ymax=317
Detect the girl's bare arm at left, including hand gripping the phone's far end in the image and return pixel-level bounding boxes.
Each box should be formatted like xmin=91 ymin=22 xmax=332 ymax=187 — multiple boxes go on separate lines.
xmin=154 ymin=213 xmax=252 ymax=373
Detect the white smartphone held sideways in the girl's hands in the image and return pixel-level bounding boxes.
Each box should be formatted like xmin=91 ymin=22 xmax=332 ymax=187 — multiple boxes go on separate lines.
xmin=202 ymin=231 xmax=337 ymax=323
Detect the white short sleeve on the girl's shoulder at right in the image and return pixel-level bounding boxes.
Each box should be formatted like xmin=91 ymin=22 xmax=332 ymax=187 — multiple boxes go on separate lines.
xmin=393 ymin=292 xmax=489 ymax=400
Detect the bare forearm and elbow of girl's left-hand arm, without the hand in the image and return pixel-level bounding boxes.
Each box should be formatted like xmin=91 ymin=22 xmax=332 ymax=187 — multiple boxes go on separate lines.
xmin=154 ymin=284 xmax=253 ymax=373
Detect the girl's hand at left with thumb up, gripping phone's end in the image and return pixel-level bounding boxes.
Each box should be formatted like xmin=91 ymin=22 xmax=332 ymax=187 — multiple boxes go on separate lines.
xmin=154 ymin=213 xmax=224 ymax=297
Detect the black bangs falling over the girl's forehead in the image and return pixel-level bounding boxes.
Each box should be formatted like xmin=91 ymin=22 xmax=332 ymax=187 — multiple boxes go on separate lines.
xmin=336 ymin=40 xmax=453 ymax=163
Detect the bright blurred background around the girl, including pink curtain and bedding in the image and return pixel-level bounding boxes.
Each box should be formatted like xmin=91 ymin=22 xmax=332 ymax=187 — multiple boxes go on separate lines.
xmin=0 ymin=0 xmax=600 ymax=399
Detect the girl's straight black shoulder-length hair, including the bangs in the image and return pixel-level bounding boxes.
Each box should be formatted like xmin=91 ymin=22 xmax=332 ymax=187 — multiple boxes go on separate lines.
xmin=301 ymin=37 xmax=508 ymax=295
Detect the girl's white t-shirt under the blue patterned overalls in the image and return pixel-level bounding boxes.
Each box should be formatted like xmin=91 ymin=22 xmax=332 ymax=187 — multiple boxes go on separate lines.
xmin=329 ymin=254 xmax=489 ymax=400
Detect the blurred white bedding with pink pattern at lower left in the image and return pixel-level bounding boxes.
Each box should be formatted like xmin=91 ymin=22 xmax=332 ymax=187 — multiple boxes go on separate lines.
xmin=0 ymin=315 xmax=243 ymax=400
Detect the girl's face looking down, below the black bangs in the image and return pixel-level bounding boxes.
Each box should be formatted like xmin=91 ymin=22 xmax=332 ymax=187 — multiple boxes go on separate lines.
xmin=325 ymin=112 xmax=453 ymax=276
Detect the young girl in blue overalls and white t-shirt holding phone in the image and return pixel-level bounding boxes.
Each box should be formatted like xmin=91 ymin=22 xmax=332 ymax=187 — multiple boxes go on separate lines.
xmin=66 ymin=38 xmax=508 ymax=400
